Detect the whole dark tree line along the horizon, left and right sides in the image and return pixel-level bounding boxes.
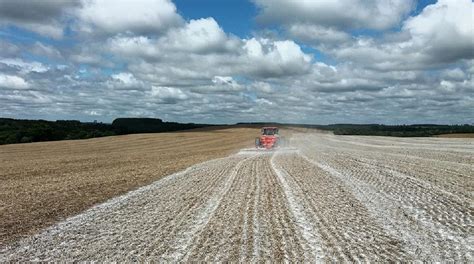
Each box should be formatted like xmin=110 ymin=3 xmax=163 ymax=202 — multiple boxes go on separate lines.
xmin=0 ymin=118 xmax=474 ymax=145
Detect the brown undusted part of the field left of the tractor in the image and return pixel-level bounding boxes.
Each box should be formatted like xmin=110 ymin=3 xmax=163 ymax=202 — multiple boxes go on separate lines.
xmin=0 ymin=128 xmax=258 ymax=248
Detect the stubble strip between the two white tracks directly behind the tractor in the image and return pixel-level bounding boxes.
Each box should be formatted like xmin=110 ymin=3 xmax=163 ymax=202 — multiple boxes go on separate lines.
xmin=183 ymin=152 xmax=305 ymax=262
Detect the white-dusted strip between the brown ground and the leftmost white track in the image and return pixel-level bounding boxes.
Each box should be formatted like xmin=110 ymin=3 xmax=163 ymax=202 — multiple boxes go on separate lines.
xmin=0 ymin=155 xmax=249 ymax=262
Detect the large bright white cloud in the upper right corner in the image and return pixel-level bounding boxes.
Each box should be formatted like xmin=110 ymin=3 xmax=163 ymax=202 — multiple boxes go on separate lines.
xmin=323 ymin=0 xmax=474 ymax=71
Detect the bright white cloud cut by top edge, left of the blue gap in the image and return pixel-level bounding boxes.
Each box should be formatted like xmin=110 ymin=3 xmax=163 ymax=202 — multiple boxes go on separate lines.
xmin=78 ymin=0 xmax=182 ymax=34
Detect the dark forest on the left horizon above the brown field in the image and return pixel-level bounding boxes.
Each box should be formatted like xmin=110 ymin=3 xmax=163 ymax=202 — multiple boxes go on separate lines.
xmin=0 ymin=118 xmax=210 ymax=145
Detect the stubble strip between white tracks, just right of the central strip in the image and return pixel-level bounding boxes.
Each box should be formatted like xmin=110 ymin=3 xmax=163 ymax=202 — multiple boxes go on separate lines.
xmin=280 ymin=152 xmax=410 ymax=262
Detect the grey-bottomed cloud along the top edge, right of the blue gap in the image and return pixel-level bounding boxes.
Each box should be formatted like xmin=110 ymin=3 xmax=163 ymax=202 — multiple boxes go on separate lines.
xmin=254 ymin=0 xmax=413 ymax=30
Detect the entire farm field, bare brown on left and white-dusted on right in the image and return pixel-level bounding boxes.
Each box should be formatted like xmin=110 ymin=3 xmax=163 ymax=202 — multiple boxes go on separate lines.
xmin=0 ymin=128 xmax=474 ymax=262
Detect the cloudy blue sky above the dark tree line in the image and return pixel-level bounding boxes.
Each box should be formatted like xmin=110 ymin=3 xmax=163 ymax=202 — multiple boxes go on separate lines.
xmin=0 ymin=0 xmax=474 ymax=124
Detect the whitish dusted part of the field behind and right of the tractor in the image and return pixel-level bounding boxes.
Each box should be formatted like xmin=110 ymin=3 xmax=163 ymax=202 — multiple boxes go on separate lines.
xmin=0 ymin=133 xmax=474 ymax=262
